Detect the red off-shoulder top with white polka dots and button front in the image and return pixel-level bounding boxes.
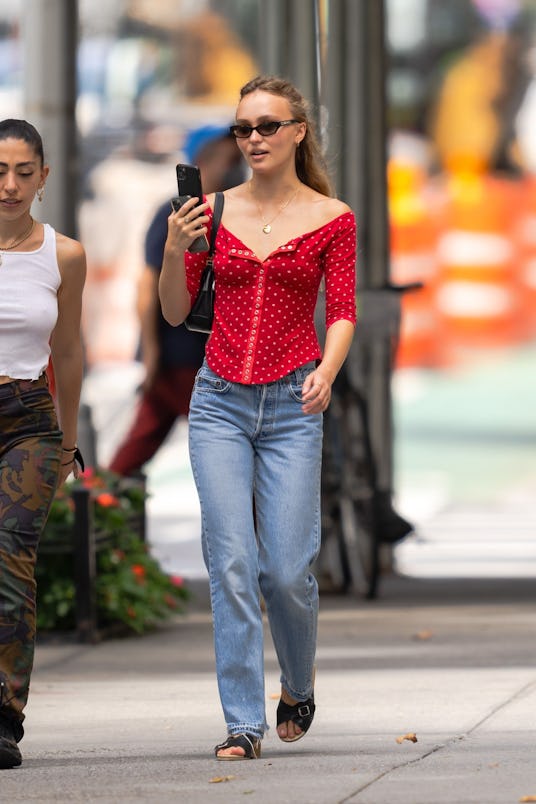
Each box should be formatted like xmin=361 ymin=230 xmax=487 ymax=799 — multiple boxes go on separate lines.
xmin=186 ymin=210 xmax=356 ymax=385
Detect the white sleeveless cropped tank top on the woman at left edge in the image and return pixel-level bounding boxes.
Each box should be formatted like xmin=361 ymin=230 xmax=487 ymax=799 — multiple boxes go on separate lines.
xmin=0 ymin=223 xmax=61 ymax=380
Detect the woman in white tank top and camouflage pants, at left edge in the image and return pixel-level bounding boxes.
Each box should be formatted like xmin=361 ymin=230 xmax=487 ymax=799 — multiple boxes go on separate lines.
xmin=0 ymin=120 xmax=86 ymax=768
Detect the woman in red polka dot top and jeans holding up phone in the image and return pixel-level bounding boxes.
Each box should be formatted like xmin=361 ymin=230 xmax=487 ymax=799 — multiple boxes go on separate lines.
xmin=160 ymin=77 xmax=356 ymax=760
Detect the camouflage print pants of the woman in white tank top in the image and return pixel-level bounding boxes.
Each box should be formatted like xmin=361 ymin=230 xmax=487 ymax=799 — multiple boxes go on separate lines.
xmin=0 ymin=376 xmax=62 ymax=739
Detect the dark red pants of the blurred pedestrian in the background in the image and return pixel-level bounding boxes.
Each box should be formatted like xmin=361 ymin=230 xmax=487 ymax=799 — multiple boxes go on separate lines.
xmin=109 ymin=366 xmax=197 ymax=475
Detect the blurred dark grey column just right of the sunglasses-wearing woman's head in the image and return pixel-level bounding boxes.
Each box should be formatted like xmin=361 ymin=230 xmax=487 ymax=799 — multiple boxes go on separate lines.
xmin=325 ymin=0 xmax=399 ymax=492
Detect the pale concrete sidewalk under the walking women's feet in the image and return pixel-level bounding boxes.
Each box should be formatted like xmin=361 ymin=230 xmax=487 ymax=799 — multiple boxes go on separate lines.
xmin=4 ymin=577 xmax=536 ymax=804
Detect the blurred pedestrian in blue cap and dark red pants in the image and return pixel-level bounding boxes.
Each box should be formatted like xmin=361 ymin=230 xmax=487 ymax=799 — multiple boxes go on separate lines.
xmin=109 ymin=125 xmax=244 ymax=475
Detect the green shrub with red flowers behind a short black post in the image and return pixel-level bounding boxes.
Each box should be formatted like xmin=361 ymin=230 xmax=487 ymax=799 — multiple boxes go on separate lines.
xmin=36 ymin=469 xmax=189 ymax=633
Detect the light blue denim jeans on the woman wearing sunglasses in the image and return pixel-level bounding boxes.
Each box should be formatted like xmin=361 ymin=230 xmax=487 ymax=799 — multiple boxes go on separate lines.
xmin=189 ymin=363 xmax=323 ymax=737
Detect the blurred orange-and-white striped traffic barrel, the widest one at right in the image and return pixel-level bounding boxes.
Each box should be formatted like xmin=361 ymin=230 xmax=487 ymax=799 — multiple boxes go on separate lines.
xmin=435 ymin=174 xmax=523 ymax=363
